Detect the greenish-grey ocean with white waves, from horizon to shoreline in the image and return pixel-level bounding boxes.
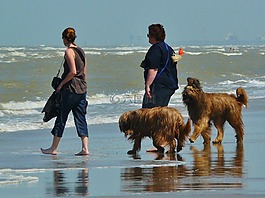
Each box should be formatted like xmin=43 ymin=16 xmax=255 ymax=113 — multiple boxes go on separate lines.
xmin=0 ymin=45 xmax=265 ymax=132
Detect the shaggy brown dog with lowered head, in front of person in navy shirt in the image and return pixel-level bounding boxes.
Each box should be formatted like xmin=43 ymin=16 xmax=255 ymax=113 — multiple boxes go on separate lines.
xmin=119 ymin=107 xmax=191 ymax=154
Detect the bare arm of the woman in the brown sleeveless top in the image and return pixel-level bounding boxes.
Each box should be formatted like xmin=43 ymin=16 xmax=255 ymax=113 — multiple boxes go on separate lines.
xmin=56 ymin=48 xmax=76 ymax=92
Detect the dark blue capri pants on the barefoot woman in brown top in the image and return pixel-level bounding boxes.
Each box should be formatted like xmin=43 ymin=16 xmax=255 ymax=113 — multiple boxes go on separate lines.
xmin=51 ymin=90 xmax=88 ymax=137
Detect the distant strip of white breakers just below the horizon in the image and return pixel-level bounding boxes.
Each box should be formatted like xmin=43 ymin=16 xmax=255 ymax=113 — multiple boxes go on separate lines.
xmin=0 ymin=45 xmax=258 ymax=63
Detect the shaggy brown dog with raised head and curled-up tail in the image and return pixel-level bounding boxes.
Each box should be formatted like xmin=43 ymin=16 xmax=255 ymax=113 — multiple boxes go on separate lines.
xmin=182 ymin=78 xmax=248 ymax=144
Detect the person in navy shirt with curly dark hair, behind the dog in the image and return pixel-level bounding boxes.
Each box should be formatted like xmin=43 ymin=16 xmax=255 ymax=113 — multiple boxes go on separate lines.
xmin=141 ymin=24 xmax=181 ymax=108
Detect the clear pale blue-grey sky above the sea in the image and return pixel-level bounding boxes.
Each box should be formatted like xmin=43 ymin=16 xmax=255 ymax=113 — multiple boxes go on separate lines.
xmin=0 ymin=0 xmax=265 ymax=46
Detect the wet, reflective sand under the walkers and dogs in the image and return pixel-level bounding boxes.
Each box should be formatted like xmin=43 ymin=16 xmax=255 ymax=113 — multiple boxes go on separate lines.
xmin=0 ymin=102 xmax=265 ymax=197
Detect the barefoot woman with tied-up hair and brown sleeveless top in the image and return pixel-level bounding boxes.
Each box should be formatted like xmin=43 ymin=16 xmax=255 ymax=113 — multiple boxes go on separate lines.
xmin=41 ymin=27 xmax=89 ymax=155
